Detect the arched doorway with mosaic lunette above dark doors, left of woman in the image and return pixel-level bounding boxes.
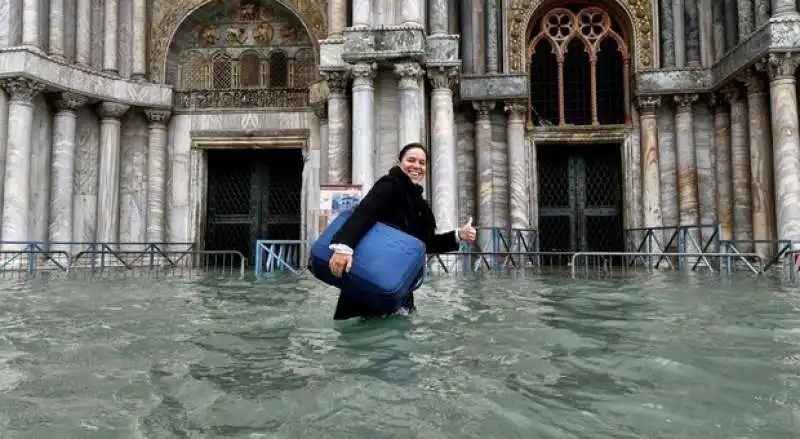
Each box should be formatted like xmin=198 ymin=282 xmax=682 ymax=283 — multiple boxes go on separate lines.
xmin=166 ymin=0 xmax=317 ymax=261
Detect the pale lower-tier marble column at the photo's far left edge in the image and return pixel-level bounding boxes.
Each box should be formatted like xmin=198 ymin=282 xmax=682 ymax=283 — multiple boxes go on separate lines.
xmin=0 ymin=78 xmax=44 ymax=250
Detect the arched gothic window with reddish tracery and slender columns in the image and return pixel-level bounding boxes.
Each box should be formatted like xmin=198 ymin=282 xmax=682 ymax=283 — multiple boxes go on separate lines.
xmin=528 ymin=6 xmax=630 ymax=125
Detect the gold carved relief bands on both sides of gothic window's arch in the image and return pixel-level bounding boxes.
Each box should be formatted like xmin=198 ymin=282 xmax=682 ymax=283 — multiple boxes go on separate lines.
xmin=506 ymin=0 xmax=653 ymax=73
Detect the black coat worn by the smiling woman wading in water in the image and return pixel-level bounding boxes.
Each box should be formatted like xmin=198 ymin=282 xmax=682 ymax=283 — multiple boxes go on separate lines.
xmin=331 ymin=166 xmax=458 ymax=320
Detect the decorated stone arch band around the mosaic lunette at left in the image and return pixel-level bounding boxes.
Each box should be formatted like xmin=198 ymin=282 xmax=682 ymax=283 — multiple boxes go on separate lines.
xmin=149 ymin=0 xmax=328 ymax=83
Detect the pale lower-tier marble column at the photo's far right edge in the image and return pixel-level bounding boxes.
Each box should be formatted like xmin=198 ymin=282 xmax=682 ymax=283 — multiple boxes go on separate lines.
xmin=764 ymin=53 xmax=800 ymax=244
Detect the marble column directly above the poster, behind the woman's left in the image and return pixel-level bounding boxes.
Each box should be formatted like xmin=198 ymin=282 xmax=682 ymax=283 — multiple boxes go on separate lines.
xmin=322 ymin=71 xmax=351 ymax=184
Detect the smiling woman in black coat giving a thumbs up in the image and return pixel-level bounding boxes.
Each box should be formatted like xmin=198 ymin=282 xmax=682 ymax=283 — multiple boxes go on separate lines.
xmin=330 ymin=143 xmax=475 ymax=320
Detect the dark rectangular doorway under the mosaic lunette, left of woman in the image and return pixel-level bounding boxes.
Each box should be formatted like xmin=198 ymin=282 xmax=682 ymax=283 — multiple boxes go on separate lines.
xmin=205 ymin=149 xmax=303 ymax=263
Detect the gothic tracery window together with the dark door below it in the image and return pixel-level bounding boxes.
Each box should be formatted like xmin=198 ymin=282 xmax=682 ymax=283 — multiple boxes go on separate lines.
xmin=528 ymin=3 xmax=631 ymax=251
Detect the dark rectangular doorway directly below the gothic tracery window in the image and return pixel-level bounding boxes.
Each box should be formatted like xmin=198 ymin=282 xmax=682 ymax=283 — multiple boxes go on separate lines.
xmin=536 ymin=144 xmax=624 ymax=252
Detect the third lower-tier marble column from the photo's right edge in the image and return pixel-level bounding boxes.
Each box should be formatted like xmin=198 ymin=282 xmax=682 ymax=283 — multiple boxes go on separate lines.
xmin=722 ymin=84 xmax=753 ymax=246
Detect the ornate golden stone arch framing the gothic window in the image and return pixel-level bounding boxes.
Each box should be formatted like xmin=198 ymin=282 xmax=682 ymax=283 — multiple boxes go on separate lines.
xmin=506 ymin=0 xmax=654 ymax=73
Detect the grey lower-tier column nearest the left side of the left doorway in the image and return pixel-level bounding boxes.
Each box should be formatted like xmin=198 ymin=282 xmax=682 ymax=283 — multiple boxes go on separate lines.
xmin=144 ymin=110 xmax=172 ymax=243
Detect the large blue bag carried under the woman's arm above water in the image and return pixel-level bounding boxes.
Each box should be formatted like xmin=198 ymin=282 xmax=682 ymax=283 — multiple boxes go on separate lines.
xmin=308 ymin=209 xmax=425 ymax=314
